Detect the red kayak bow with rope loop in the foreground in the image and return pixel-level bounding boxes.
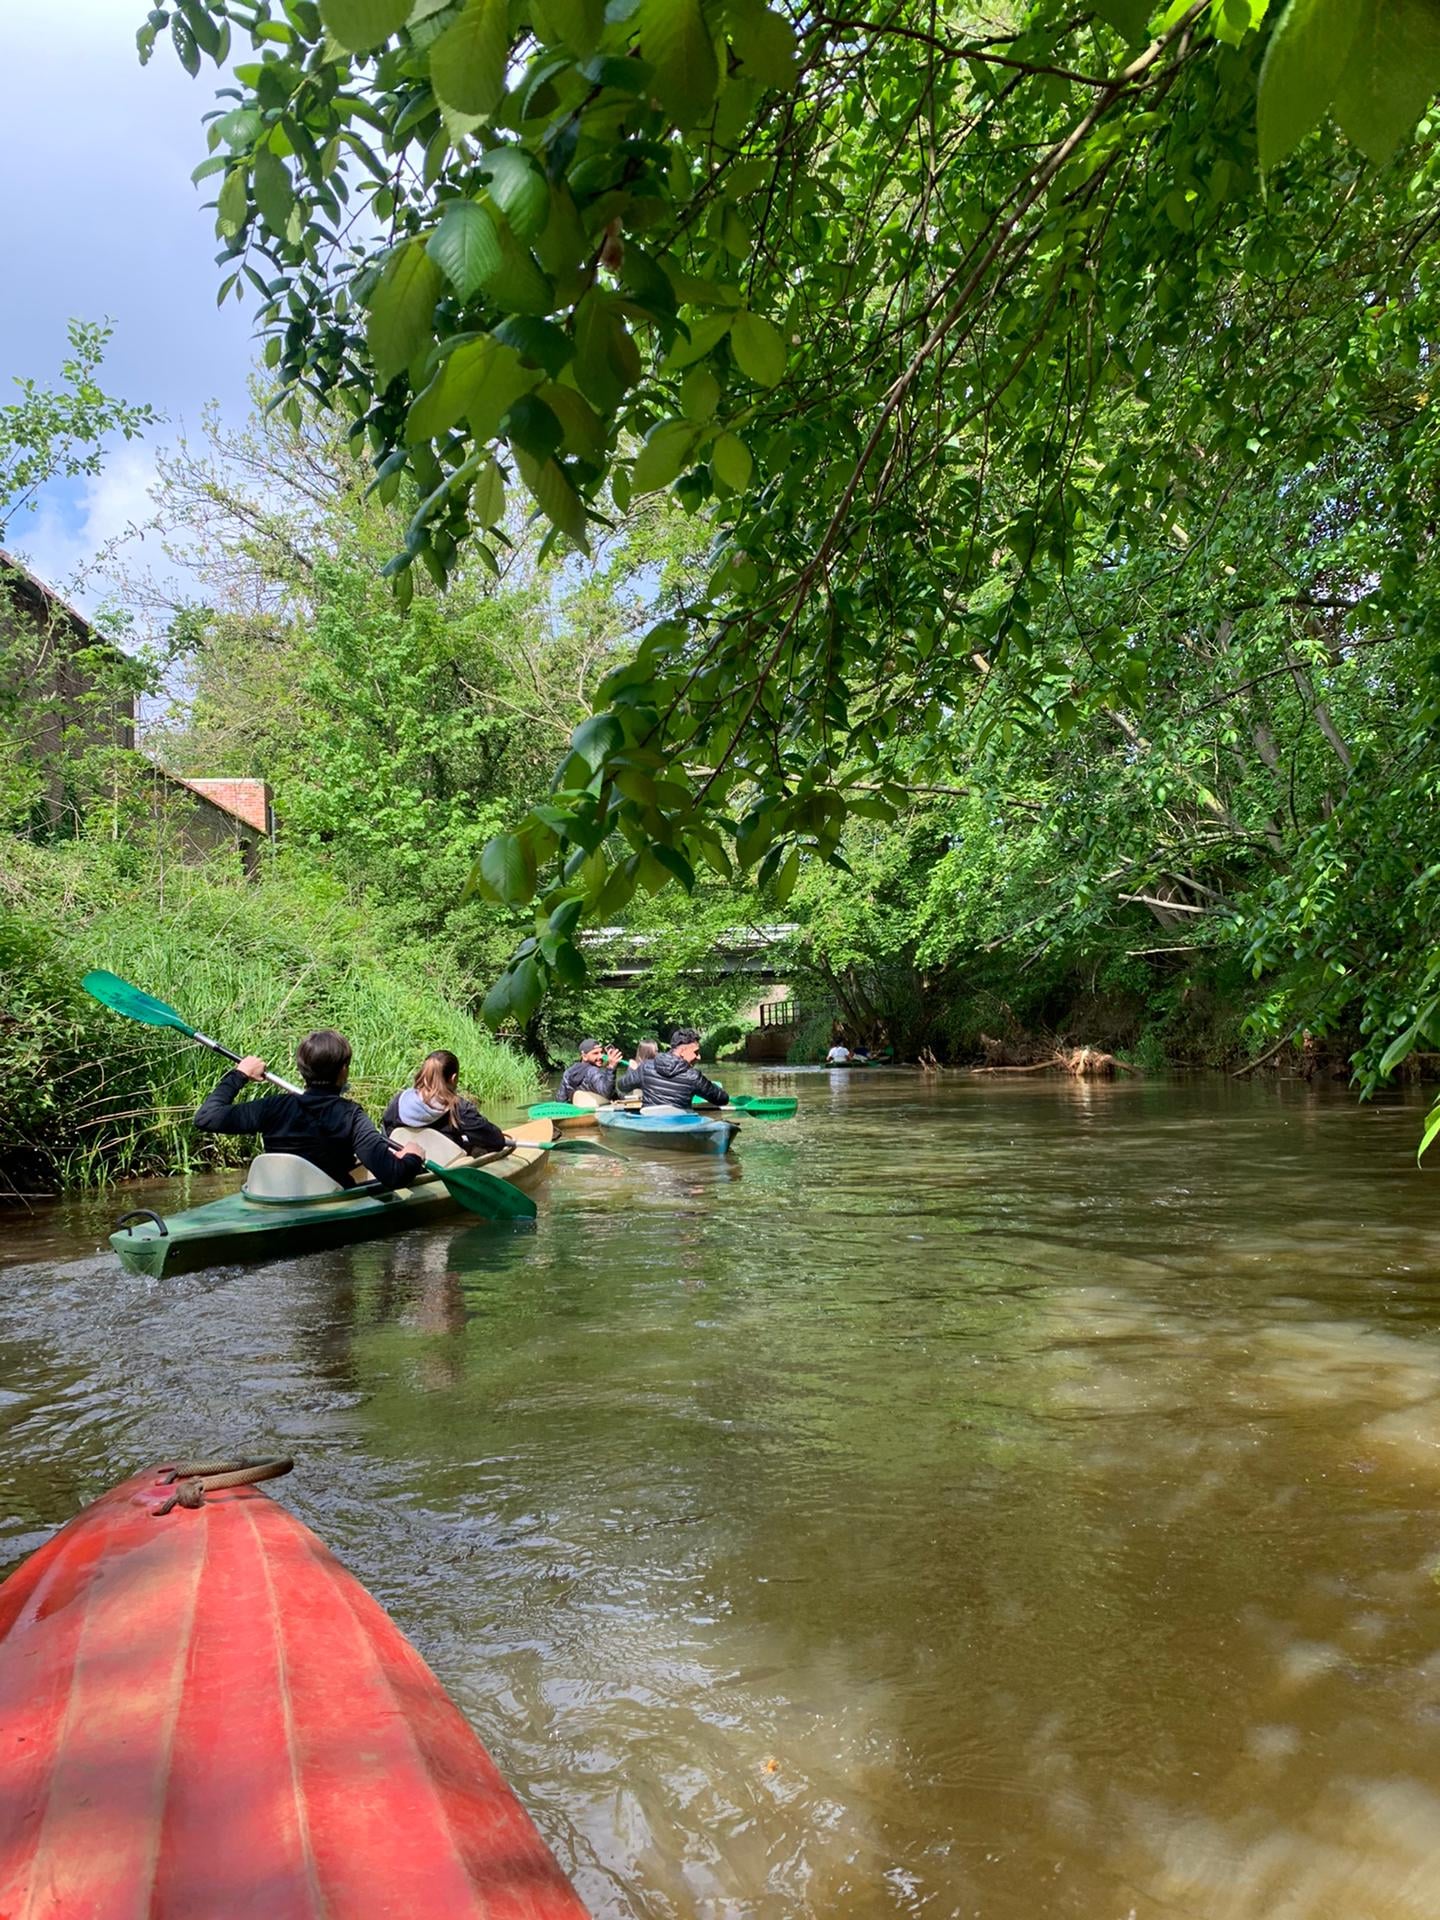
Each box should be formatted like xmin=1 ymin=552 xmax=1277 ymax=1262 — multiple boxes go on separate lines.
xmin=0 ymin=1463 xmax=586 ymax=1920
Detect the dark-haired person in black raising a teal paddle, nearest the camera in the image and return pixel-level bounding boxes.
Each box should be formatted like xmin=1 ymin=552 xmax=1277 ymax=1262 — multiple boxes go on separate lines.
xmin=194 ymin=1027 xmax=424 ymax=1187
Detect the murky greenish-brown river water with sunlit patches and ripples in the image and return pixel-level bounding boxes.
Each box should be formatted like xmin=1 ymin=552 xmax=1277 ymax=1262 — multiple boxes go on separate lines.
xmin=0 ymin=1071 xmax=1440 ymax=1920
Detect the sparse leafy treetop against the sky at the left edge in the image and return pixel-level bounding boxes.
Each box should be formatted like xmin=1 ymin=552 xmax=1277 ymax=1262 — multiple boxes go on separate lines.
xmin=0 ymin=321 xmax=159 ymax=541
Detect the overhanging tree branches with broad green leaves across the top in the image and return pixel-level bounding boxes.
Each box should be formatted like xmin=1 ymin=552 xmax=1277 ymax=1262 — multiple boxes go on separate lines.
xmin=155 ymin=0 xmax=1440 ymax=1018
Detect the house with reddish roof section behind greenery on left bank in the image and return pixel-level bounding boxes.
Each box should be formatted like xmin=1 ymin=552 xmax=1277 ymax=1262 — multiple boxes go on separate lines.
xmin=0 ymin=549 xmax=275 ymax=872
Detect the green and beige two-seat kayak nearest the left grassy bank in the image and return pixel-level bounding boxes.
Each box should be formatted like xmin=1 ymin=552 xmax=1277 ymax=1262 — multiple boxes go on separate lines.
xmin=109 ymin=1119 xmax=555 ymax=1282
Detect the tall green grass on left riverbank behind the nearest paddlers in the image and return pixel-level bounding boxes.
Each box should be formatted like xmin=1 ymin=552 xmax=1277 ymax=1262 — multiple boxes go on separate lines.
xmin=0 ymin=841 xmax=536 ymax=1198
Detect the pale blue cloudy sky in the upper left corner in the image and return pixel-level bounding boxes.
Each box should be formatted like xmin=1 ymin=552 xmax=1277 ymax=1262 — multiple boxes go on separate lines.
xmin=0 ymin=0 xmax=255 ymax=611
